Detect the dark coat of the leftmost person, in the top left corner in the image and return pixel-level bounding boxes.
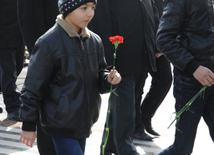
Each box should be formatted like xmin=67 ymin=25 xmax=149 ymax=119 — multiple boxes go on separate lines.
xmin=0 ymin=0 xmax=23 ymax=48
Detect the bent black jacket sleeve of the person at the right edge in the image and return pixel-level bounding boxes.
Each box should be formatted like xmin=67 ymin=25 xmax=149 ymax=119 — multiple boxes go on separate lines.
xmin=156 ymin=0 xmax=199 ymax=74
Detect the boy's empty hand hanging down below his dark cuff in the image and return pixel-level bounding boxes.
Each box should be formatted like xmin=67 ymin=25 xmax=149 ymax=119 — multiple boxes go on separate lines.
xmin=20 ymin=131 xmax=36 ymax=147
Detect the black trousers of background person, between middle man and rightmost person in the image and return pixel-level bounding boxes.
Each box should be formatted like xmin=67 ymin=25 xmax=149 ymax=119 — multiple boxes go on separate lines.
xmin=135 ymin=56 xmax=172 ymax=128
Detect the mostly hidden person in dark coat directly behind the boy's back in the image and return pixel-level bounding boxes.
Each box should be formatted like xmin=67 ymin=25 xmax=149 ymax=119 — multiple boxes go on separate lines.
xmin=18 ymin=0 xmax=59 ymax=155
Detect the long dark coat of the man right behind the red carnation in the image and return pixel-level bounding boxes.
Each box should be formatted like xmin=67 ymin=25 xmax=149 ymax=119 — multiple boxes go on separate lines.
xmin=88 ymin=0 xmax=156 ymax=75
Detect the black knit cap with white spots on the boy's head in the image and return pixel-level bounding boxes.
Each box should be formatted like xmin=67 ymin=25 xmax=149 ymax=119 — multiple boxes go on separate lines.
xmin=58 ymin=0 xmax=97 ymax=18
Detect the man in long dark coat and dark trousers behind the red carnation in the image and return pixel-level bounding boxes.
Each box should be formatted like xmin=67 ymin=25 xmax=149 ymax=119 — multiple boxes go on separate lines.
xmin=89 ymin=0 xmax=156 ymax=155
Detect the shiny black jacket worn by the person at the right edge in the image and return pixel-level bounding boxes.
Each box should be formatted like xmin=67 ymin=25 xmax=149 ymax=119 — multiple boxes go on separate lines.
xmin=157 ymin=0 xmax=214 ymax=76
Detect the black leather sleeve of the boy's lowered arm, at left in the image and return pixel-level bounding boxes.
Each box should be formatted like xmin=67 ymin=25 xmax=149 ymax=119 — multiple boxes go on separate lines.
xmin=20 ymin=39 xmax=54 ymax=131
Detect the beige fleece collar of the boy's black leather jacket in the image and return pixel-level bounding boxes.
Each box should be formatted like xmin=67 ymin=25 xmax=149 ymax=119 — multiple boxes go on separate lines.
xmin=56 ymin=14 xmax=90 ymax=38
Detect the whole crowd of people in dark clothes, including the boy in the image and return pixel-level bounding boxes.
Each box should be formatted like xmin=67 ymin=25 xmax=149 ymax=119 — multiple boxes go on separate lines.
xmin=0 ymin=0 xmax=214 ymax=155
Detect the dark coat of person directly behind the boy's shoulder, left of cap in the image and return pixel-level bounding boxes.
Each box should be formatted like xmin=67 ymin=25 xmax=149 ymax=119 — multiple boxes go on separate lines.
xmin=18 ymin=0 xmax=59 ymax=53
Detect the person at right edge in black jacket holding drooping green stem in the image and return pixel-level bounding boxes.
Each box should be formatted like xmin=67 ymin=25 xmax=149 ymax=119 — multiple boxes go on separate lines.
xmin=157 ymin=0 xmax=214 ymax=155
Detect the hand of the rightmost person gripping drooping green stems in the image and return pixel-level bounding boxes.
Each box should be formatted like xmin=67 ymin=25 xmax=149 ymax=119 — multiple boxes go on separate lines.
xmin=193 ymin=66 xmax=214 ymax=87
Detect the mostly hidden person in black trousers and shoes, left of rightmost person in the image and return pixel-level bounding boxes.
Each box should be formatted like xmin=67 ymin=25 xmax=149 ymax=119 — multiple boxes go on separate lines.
xmin=133 ymin=0 xmax=172 ymax=141
